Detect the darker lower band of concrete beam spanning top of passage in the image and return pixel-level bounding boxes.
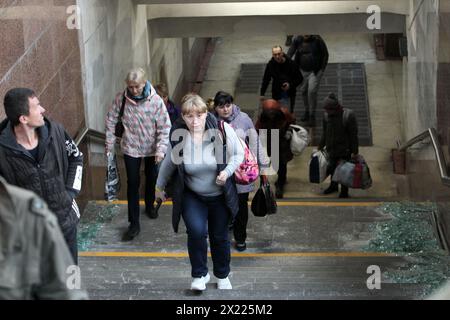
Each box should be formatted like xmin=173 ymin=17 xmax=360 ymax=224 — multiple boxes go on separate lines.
xmin=149 ymin=13 xmax=406 ymax=38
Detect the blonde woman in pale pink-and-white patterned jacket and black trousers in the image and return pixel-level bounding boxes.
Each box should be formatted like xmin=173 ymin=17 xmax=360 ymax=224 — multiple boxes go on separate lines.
xmin=105 ymin=68 xmax=171 ymax=241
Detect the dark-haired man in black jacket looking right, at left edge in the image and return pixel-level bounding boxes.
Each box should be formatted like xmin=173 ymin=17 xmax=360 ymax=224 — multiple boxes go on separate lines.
xmin=0 ymin=88 xmax=83 ymax=263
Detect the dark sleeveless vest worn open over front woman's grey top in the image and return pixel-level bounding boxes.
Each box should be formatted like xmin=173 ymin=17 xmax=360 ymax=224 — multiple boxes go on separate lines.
xmin=167 ymin=113 xmax=239 ymax=232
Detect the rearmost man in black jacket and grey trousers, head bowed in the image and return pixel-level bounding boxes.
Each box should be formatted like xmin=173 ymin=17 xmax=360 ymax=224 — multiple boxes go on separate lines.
xmin=287 ymin=35 xmax=328 ymax=125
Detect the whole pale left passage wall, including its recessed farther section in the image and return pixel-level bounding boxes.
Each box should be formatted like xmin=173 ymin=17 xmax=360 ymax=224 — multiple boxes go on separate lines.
xmin=78 ymin=0 xmax=204 ymax=131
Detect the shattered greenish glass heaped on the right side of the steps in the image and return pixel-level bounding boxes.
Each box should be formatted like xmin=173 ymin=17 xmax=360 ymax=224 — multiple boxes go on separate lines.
xmin=364 ymin=202 xmax=450 ymax=295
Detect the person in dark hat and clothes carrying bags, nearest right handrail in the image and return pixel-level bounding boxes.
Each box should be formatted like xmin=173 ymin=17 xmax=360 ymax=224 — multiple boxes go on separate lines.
xmin=319 ymin=93 xmax=359 ymax=198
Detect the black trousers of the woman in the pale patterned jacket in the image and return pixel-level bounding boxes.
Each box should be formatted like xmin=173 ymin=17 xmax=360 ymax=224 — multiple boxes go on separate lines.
xmin=124 ymin=155 xmax=158 ymax=226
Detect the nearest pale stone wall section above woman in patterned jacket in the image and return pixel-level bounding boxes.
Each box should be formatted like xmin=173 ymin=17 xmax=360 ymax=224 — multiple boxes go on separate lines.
xmin=78 ymin=0 xmax=151 ymax=131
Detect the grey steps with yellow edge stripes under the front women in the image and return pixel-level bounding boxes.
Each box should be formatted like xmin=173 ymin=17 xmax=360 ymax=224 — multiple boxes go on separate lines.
xmin=80 ymin=201 xmax=425 ymax=300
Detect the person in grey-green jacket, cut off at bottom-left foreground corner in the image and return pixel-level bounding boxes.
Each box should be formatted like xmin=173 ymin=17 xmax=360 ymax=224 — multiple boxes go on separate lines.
xmin=0 ymin=177 xmax=87 ymax=300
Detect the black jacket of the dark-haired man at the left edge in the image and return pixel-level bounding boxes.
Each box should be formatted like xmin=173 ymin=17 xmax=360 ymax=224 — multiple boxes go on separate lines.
xmin=0 ymin=119 xmax=83 ymax=233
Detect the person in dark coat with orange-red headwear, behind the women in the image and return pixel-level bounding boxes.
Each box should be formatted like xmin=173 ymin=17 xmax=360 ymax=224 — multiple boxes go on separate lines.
xmin=255 ymin=99 xmax=295 ymax=199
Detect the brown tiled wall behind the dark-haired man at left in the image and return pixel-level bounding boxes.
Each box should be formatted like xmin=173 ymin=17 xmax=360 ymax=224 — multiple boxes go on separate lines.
xmin=0 ymin=0 xmax=84 ymax=135
